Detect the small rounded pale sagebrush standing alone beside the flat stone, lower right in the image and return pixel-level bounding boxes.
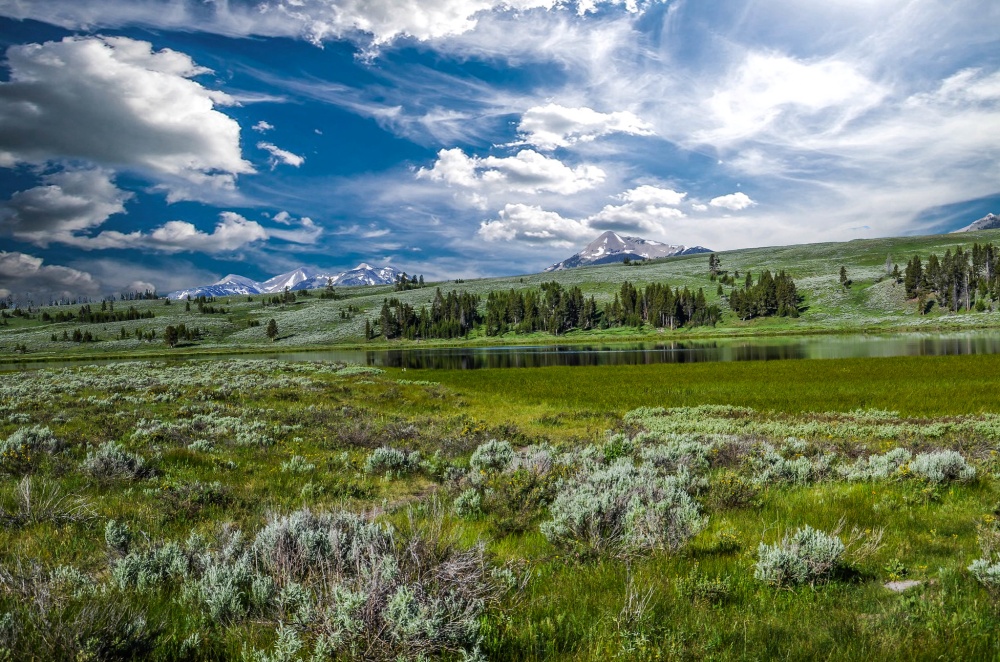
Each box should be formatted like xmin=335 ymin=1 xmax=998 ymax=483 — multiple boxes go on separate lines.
xmin=754 ymin=526 xmax=845 ymax=587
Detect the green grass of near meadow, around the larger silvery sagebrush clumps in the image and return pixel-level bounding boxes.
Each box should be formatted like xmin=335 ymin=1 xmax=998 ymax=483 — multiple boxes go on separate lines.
xmin=0 ymin=360 xmax=1000 ymax=660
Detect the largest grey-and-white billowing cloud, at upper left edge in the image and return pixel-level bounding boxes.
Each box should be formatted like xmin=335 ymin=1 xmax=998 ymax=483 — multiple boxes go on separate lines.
xmin=0 ymin=36 xmax=253 ymax=196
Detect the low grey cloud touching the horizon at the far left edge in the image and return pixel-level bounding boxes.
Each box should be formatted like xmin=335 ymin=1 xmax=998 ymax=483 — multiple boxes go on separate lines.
xmin=0 ymin=251 xmax=100 ymax=297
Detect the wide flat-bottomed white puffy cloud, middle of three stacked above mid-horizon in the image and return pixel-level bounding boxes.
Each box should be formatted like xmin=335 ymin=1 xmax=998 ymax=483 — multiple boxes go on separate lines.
xmin=417 ymin=147 xmax=606 ymax=202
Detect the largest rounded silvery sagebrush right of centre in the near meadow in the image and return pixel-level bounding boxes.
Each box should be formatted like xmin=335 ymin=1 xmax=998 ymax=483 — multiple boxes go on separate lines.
xmin=541 ymin=460 xmax=706 ymax=556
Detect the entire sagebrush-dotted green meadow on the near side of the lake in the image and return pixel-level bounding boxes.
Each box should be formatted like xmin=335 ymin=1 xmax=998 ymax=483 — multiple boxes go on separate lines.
xmin=0 ymin=358 xmax=1000 ymax=661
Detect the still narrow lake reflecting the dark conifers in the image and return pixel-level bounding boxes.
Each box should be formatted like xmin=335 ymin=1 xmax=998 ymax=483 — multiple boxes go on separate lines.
xmin=0 ymin=330 xmax=1000 ymax=370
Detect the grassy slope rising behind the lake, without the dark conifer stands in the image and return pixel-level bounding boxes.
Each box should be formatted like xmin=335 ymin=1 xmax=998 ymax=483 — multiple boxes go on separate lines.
xmin=0 ymin=231 xmax=1000 ymax=358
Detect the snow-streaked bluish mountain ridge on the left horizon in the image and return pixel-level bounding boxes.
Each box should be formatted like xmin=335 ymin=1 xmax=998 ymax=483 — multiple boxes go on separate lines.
xmin=167 ymin=262 xmax=403 ymax=299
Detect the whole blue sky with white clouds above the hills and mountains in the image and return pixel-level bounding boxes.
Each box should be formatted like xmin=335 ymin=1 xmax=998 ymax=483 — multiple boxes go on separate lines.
xmin=0 ymin=0 xmax=1000 ymax=297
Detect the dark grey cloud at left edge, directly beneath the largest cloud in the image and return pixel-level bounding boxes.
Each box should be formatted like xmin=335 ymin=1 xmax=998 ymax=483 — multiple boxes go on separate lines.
xmin=0 ymin=168 xmax=132 ymax=247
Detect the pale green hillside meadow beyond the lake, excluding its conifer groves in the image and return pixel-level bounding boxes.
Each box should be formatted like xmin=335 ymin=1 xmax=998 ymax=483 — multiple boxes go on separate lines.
xmin=0 ymin=230 xmax=1000 ymax=361
